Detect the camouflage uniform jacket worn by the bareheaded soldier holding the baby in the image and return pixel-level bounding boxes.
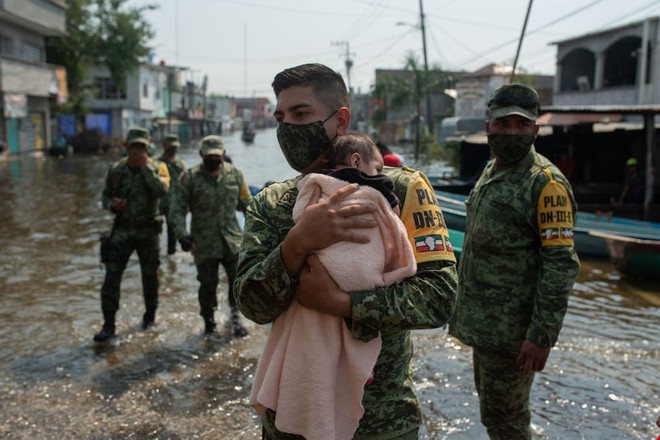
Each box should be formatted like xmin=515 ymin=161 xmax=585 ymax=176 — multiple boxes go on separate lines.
xmin=234 ymin=168 xmax=457 ymax=439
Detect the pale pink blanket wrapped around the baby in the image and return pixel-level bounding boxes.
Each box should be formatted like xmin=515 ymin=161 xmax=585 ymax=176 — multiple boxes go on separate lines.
xmin=250 ymin=174 xmax=417 ymax=440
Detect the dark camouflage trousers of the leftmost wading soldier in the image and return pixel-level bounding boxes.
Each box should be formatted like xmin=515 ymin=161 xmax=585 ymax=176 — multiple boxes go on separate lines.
xmin=101 ymin=232 xmax=160 ymax=316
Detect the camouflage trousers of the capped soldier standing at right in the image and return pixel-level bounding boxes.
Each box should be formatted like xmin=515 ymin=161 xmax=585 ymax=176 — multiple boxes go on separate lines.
xmin=472 ymin=347 xmax=534 ymax=440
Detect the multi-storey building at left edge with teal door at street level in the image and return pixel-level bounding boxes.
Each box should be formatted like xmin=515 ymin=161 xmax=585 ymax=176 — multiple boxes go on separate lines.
xmin=0 ymin=0 xmax=67 ymax=153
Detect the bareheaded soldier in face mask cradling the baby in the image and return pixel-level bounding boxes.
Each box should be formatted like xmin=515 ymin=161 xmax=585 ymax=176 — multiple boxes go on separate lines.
xmin=234 ymin=64 xmax=456 ymax=439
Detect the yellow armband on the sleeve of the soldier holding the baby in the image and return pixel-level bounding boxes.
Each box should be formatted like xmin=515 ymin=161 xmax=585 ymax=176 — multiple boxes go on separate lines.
xmin=401 ymin=174 xmax=456 ymax=264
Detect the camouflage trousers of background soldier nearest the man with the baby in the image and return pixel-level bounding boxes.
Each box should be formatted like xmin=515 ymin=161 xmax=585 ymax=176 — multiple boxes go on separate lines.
xmin=195 ymin=254 xmax=238 ymax=318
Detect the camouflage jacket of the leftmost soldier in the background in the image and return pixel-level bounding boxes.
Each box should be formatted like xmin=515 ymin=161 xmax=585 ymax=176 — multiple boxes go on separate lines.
xmin=101 ymin=157 xmax=169 ymax=234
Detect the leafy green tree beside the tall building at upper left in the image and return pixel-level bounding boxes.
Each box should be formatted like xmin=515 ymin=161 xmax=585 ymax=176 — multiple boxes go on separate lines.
xmin=46 ymin=0 xmax=156 ymax=118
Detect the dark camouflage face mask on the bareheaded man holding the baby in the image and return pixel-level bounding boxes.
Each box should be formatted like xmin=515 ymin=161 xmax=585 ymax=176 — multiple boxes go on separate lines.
xmin=277 ymin=110 xmax=337 ymax=172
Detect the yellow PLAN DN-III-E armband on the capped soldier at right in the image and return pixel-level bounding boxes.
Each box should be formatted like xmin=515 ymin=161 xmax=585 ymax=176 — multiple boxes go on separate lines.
xmin=536 ymin=170 xmax=575 ymax=247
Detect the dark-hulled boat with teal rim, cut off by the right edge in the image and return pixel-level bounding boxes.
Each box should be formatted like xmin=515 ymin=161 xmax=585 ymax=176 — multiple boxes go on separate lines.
xmin=589 ymin=231 xmax=660 ymax=279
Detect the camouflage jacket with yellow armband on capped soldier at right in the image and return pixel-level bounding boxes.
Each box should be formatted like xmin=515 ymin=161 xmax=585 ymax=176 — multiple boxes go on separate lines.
xmin=449 ymin=148 xmax=580 ymax=354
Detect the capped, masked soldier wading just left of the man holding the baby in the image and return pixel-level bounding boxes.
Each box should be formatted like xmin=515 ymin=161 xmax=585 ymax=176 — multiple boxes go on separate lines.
xmin=170 ymin=135 xmax=252 ymax=337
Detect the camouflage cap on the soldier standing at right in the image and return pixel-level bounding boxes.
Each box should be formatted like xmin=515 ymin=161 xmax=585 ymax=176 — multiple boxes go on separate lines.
xmin=488 ymin=84 xmax=539 ymax=121
